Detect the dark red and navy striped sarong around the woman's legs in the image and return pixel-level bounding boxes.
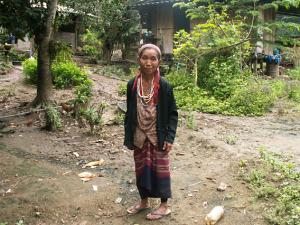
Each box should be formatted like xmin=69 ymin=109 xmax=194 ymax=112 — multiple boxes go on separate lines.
xmin=134 ymin=139 xmax=171 ymax=199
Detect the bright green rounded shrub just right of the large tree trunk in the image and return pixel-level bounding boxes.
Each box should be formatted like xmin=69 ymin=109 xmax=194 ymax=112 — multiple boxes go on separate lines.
xmin=51 ymin=61 xmax=87 ymax=88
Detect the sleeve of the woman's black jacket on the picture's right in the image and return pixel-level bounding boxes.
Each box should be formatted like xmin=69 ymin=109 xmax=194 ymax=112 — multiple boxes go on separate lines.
xmin=166 ymin=86 xmax=178 ymax=144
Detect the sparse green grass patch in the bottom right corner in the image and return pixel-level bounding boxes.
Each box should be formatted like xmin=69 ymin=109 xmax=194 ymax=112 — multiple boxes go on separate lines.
xmin=240 ymin=148 xmax=300 ymax=225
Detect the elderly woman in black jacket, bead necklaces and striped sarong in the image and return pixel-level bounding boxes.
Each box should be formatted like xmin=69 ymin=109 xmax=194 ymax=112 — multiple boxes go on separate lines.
xmin=124 ymin=44 xmax=178 ymax=220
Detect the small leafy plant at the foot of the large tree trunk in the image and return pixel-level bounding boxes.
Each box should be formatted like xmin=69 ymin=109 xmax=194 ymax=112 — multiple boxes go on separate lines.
xmin=45 ymin=104 xmax=62 ymax=131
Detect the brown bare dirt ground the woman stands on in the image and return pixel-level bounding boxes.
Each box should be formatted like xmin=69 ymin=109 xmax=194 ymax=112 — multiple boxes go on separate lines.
xmin=0 ymin=67 xmax=300 ymax=225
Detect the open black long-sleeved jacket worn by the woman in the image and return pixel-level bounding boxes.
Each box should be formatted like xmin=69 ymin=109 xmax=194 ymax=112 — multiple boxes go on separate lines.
xmin=124 ymin=78 xmax=178 ymax=150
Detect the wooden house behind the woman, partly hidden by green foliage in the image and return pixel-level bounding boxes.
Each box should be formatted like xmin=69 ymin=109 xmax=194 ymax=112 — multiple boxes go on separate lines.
xmin=133 ymin=0 xmax=300 ymax=65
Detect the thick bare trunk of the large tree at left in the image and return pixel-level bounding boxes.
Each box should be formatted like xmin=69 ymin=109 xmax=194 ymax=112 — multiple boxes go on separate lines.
xmin=32 ymin=0 xmax=58 ymax=105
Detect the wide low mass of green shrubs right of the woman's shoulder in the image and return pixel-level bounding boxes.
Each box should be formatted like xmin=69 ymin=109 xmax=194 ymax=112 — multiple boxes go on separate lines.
xmin=166 ymin=71 xmax=286 ymax=116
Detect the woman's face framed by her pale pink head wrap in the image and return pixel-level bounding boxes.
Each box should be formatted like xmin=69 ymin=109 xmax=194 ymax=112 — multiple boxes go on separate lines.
xmin=139 ymin=48 xmax=160 ymax=75
